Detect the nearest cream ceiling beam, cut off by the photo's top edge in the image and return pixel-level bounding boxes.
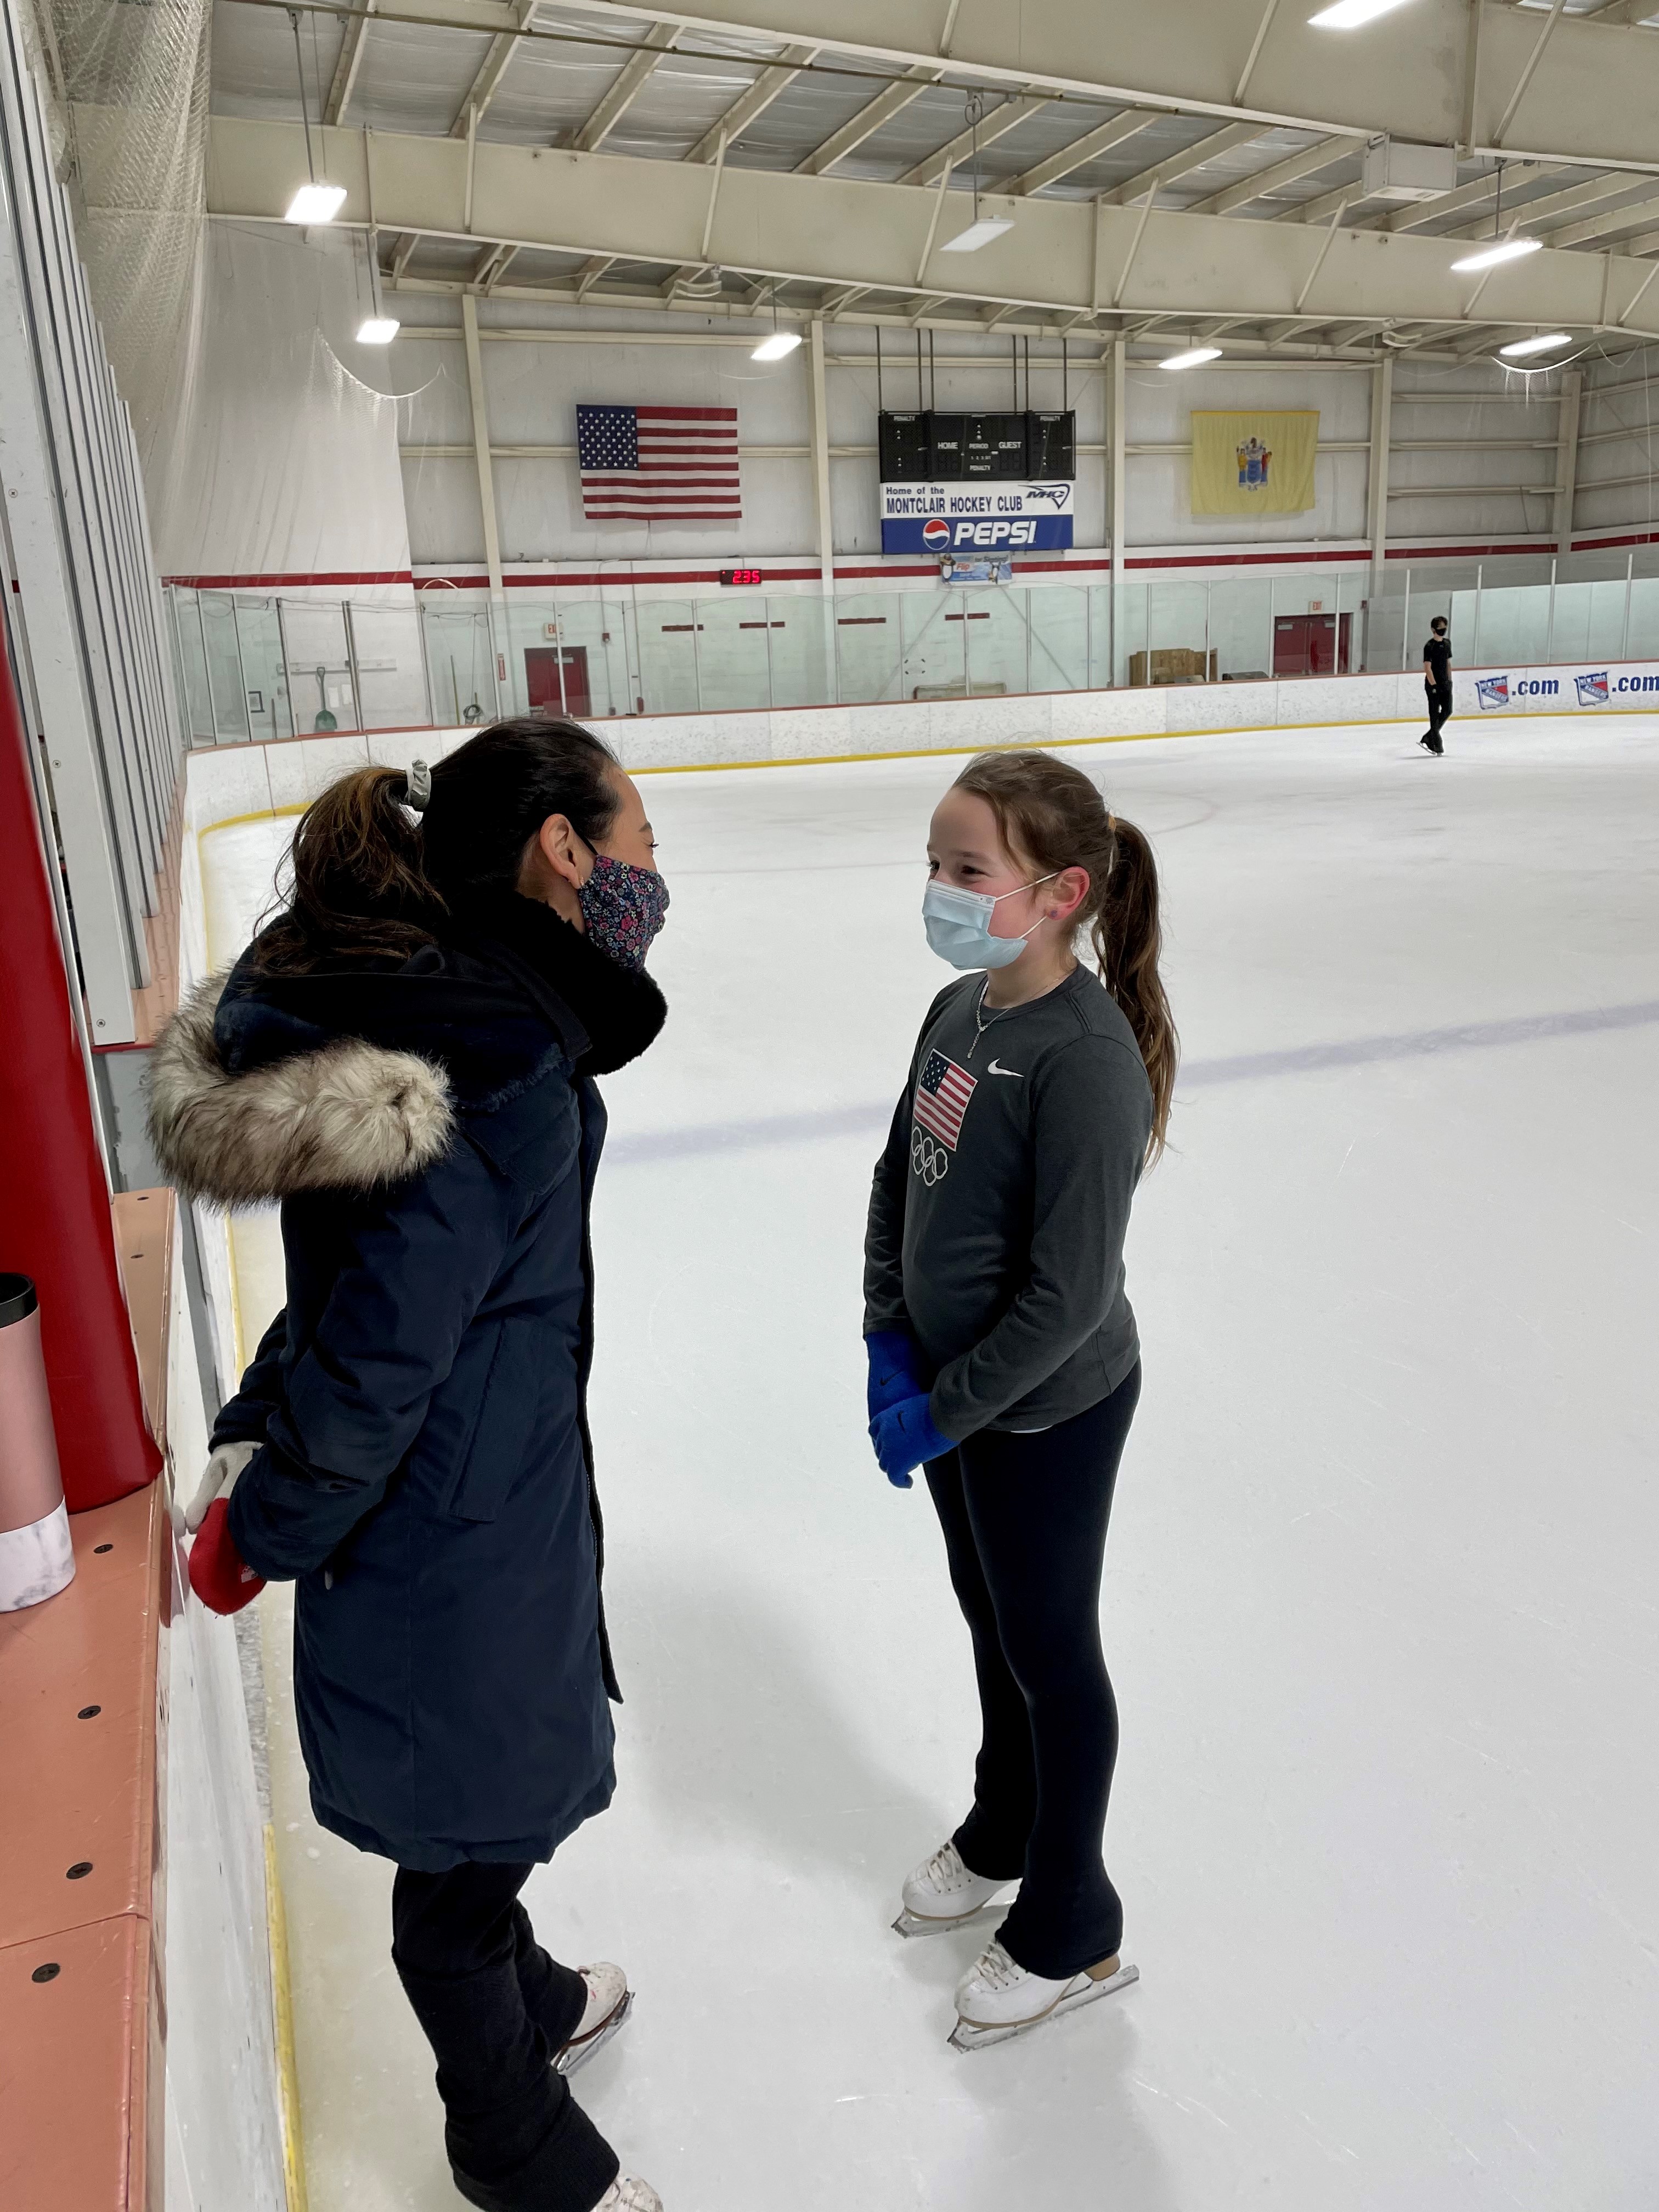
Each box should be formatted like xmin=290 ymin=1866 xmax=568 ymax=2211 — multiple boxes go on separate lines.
xmin=334 ymin=0 xmax=1659 ymax=172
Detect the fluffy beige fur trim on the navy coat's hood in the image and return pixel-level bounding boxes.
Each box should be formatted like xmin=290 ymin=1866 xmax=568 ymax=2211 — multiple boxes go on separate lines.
xmin=150 ymin=975 xmax=456 ymax=1205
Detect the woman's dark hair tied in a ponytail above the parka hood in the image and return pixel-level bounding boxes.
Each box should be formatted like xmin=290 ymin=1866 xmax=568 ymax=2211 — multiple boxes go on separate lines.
xmin=259 ymin=714 xmax=622 ymax=973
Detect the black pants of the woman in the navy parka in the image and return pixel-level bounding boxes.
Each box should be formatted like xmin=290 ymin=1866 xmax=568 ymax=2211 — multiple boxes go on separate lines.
xmin=392 ymin=1860 xmax=617 ymax=2212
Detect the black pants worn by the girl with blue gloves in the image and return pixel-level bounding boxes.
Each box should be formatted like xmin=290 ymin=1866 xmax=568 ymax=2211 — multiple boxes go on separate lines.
xmin=927 ymin=1367 xmax=1142 ymax=1980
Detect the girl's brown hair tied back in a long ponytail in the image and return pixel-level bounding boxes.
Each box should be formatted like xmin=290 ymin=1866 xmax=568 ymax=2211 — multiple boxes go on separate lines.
xmin=956 ymin=752 xmax=1179 ymax=1166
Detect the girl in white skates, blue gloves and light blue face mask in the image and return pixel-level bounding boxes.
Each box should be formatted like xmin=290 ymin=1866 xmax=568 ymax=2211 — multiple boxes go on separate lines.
xmin=865 ymin=752 xmax=1177 ymax=2051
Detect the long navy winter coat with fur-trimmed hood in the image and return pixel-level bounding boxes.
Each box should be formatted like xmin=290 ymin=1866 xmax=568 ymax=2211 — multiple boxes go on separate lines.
xmin=153 ymin=898 xmax=664 ymax=1871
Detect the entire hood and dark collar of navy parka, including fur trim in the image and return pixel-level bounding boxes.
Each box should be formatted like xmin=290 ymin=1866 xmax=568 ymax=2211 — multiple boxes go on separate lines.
xmin=150 ymin=896 xmax=668 ymax=1205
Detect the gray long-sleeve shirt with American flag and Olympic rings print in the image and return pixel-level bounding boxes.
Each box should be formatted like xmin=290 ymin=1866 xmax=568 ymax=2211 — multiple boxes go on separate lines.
xmin=865 ymin=967 xmax=1153 ymax=1438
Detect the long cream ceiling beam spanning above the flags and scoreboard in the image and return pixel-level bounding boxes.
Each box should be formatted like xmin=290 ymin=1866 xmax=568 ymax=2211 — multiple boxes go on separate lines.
xmin=198 ymin=115 xmax=1659 ymax=338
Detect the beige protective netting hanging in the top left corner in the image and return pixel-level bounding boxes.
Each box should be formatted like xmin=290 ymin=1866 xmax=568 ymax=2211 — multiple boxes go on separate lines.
xmin=22 ymin=0 xmax=210 ymax=458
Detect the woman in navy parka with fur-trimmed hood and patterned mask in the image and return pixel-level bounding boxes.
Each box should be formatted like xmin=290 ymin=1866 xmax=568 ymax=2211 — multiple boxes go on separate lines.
xmin=153 ymin=721 xmax=668 ymax=2212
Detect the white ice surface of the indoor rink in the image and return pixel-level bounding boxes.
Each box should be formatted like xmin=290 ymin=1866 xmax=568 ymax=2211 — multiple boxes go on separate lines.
xmin=204 ymin=716 xmax=1659 ymax=2212
